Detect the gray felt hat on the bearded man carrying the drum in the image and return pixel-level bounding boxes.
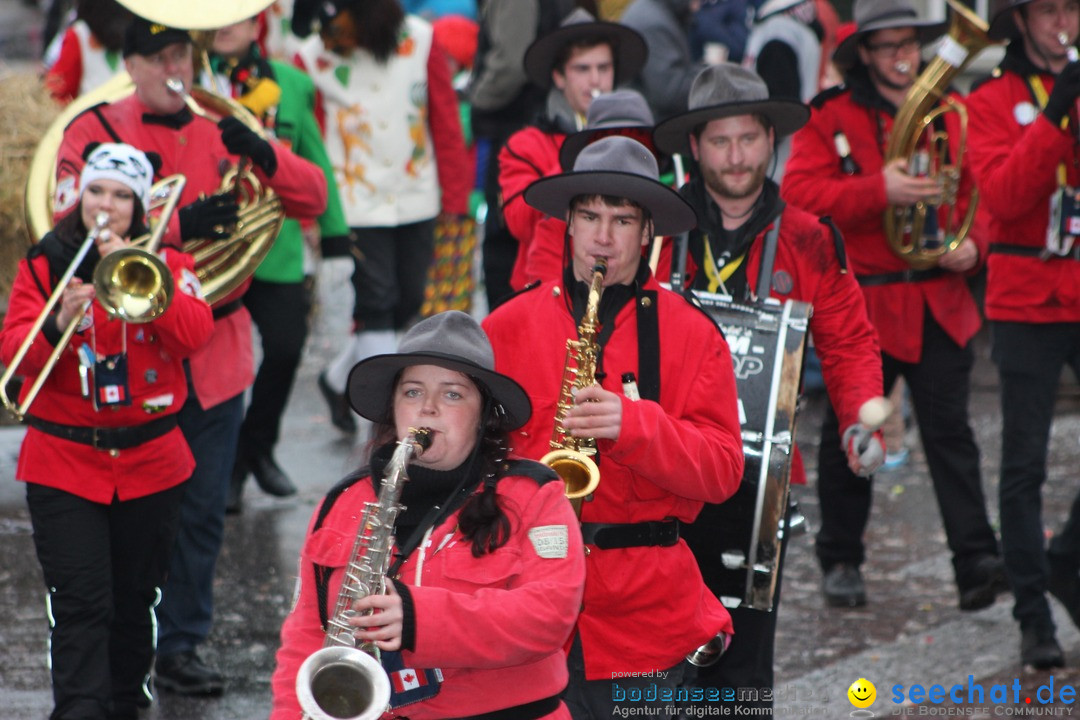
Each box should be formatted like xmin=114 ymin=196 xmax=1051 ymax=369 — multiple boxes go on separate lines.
xmin=652 ymin=63 xmax=810 ymax=154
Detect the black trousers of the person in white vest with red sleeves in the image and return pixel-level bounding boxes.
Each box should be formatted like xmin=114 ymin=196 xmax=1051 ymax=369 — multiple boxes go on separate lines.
xmin=352 ymin=220 xmax=435 ymax=332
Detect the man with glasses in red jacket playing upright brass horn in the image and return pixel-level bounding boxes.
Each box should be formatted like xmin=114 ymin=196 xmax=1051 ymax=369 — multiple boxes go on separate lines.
xmin=781 ymin=0 xmax=1007 ymax=610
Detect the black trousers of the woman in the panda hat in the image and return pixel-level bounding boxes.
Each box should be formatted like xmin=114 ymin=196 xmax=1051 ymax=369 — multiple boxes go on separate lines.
xmin=26 ymin=479 xmax=185 ymax=720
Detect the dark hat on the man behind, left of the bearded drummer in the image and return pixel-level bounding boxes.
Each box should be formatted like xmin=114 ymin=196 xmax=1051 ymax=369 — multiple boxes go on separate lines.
xmin=525 ymin=8 xmax=649 ymax=87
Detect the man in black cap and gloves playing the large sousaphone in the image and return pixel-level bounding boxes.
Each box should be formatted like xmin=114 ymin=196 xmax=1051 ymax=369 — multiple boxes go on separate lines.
xmin=55 ymin=18 xmax=326 ymax=694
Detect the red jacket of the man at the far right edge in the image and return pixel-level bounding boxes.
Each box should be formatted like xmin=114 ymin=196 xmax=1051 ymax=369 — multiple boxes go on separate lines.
xmin=968 ymin=47 xmax=1080 ymax=323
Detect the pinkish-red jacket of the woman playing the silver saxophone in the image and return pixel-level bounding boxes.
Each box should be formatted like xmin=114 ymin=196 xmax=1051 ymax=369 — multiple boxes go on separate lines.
xmin=270 ymin=476 xmax=585 ymax=720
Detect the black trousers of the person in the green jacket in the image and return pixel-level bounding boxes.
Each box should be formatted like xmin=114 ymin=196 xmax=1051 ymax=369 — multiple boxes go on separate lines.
xmin=240 ymin=280 xmax=311 ymax=452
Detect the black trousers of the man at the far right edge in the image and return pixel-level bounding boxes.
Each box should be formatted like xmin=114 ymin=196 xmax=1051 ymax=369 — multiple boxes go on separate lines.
xmin=990 ymin=323 xmax=1080 ymax=628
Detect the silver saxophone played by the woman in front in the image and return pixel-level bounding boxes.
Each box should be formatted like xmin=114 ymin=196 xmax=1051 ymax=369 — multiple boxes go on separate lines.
xmin=296 ymin=427 xmax=431 ymax=720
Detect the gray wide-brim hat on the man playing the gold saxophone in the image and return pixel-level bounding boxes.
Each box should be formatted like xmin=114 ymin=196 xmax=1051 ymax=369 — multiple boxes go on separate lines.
xmin=524 ymin=135 xmax=698 ymax=235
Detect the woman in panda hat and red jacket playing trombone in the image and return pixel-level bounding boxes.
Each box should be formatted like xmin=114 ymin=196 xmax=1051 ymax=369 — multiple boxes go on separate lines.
xmin=0 ymin=144 xmax=213 ymax=720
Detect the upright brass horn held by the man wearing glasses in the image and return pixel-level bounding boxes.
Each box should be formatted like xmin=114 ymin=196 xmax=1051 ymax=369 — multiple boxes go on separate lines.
xmin=885 ymin=0 xmax=994 ymax=270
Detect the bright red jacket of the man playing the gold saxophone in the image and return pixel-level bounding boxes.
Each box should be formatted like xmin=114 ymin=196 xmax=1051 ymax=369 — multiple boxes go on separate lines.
xmin=483 ymin=277 xmax=743 ymax=680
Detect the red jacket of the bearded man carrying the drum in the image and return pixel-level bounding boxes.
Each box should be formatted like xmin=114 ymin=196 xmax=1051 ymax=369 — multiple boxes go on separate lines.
xmin=657 ymin=185 xmax=882 ymax=484
